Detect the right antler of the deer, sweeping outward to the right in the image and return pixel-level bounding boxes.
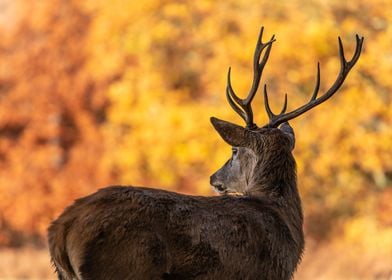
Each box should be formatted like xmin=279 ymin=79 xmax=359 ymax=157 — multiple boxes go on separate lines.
xmin=264 ymin=35 xmax=364 ymax=127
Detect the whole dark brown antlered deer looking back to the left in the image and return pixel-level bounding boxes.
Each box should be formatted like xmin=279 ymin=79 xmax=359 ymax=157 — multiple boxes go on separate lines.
xmin=48 ymin=27 xmax=364 ymax=280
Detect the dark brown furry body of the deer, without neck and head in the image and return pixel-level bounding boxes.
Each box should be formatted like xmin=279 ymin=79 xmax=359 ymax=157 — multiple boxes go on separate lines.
xmin=49 ymin=183 xmax=303 ymax=279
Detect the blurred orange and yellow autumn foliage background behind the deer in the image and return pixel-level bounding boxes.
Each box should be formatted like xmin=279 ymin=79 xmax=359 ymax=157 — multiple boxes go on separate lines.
xmin=0 ymin=0 xmax=392 ymax=279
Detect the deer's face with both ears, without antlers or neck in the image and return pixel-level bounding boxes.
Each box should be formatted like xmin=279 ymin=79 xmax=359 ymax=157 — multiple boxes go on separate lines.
xmin=210 ymin=118 xmax=295 ymax=194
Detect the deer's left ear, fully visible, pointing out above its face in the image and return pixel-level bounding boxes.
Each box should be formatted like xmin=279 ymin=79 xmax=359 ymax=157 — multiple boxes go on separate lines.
xmin=211 ymin=117 xmax=253 ymax=147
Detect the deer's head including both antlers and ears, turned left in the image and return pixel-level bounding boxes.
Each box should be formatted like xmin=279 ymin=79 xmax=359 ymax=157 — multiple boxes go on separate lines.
xmin=210 ymin=27 xmax=363 ymax=195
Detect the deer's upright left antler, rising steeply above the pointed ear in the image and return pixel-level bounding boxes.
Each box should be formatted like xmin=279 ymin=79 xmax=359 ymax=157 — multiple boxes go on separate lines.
xmin=226 ymin=27 xmax=275 ymax=129
